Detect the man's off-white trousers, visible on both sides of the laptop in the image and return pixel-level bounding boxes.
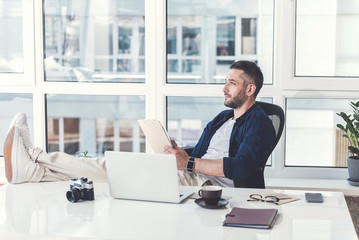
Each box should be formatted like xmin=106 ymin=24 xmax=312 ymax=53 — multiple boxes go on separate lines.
xmin=31 ymin=148 xmax=208 ymax=186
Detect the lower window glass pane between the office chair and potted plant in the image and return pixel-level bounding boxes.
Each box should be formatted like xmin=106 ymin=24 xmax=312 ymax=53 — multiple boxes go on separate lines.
xmin=285 ymin=98 xmax=357 ymax=167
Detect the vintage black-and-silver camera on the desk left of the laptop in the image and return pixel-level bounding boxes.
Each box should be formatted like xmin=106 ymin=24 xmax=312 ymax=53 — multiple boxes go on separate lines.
xmin=66 ymin=177 xmax=95 ymax=202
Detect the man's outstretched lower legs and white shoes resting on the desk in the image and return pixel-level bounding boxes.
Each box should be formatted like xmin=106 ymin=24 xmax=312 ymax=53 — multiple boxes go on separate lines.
xmin=4 ymin=114 xmax=107 ymax=183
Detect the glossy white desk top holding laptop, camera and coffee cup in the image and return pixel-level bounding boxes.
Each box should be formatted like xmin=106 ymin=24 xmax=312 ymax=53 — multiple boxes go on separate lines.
xmin=0 ymin=182 xmax=357 ymax=240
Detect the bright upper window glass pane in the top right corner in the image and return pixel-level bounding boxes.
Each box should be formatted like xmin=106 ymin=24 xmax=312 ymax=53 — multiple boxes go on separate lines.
xmin=295 ymin=0 xmax=359 ymax=77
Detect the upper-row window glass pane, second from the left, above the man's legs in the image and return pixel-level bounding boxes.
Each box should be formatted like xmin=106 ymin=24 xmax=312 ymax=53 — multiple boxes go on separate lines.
xmin=44 ymin=0 xmax=145 ymax=82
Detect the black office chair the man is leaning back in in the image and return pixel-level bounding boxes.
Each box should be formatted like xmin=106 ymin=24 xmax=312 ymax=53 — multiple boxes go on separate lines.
xmin=233 ymin=102 xmax=285 ymax=188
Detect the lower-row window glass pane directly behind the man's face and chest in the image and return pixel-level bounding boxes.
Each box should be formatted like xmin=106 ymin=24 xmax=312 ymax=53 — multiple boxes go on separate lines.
xmin=167 ymin=97 xmax=272 ymax=164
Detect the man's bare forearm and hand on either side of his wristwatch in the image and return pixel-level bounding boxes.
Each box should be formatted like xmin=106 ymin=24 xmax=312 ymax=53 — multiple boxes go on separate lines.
xmin=165 ymin=141 xmax=224 ymax=177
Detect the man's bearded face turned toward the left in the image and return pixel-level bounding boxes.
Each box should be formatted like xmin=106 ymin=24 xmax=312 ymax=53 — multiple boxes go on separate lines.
xmin=223 ymin=69 xmax=248 ymax=109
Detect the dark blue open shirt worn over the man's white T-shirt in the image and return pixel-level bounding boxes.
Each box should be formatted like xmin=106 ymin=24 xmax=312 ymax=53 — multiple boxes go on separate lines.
xmin=191 ymin=104 xmax=275 ymax=182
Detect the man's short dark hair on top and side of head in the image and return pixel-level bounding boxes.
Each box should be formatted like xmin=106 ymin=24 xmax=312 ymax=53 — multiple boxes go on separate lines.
xmin=229 ymin=61 xmax=263 ymax=98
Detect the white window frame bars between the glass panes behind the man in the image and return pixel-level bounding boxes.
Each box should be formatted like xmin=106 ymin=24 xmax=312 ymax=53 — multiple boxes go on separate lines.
xmin=0 ymin=0 xmax=359 ymax=179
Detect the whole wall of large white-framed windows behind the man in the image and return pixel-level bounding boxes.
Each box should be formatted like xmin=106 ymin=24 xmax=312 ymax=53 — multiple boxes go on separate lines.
xmin=0 ymin=0 xmax=359 ymax=182
